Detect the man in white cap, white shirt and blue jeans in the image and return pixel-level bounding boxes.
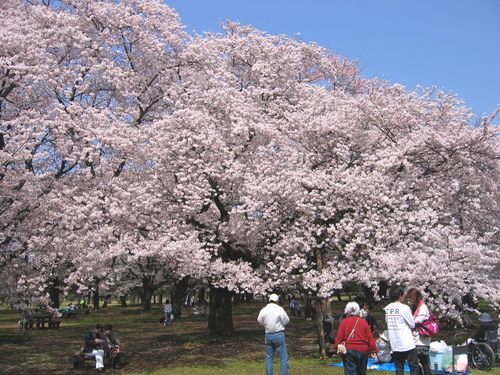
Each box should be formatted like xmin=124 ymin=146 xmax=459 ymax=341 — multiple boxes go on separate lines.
xmin=257 ymin=293 xmax=290 ymax=375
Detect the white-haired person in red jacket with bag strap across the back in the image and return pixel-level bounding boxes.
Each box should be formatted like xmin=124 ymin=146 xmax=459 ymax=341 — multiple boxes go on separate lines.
xmin=334 ymin=302 xmax=377 ymax=375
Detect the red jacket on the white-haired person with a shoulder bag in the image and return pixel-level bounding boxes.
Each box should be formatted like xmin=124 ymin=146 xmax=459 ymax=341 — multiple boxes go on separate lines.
xmin=334 ymin=316 xmax=377 ymax=354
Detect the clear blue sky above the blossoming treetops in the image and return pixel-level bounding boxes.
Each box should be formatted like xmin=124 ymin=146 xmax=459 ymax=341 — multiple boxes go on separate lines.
xmin=164 ymin=0 xmax=500 ymax=115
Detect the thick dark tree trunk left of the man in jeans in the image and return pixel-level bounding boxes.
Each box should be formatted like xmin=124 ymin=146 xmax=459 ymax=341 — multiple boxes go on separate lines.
xmin=208 ymin=287 xmax=234 ymax=336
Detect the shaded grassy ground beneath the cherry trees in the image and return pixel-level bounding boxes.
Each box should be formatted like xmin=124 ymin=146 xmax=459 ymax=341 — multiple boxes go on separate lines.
xmin=0 ymin=302 xmax=500 ymax=375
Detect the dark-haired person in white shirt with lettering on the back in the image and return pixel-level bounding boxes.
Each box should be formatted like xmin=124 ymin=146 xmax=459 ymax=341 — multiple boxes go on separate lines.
xmin=384 ymin=286 xmax=419 ymax=375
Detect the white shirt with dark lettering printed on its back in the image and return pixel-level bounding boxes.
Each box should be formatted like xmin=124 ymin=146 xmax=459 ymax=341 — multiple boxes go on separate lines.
xmin=384 ymin=302 xmax=415 ymax=352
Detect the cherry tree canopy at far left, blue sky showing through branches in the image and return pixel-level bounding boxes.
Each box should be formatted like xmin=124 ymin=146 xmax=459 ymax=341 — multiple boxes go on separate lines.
xmin=0 ymin=0 xmax=188 ymax=308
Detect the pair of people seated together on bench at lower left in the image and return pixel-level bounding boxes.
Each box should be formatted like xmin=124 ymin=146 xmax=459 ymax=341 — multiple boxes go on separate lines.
xmin=84 ymin=324 xmax=122 ymax=372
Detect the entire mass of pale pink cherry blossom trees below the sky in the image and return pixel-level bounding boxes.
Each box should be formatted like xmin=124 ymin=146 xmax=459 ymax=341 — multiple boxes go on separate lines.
xmin=0 ymin=0 xmax=499 ymax=350
